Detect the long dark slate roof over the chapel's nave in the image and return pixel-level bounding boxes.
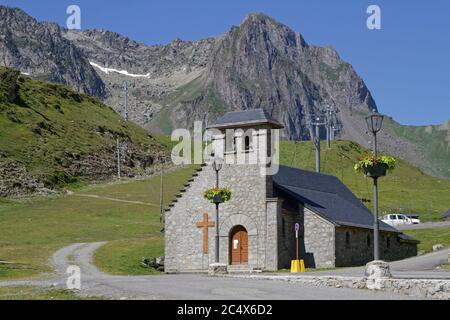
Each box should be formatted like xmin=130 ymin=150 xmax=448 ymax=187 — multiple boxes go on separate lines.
xmin=273 ymin=166 xmax=399 ymax=233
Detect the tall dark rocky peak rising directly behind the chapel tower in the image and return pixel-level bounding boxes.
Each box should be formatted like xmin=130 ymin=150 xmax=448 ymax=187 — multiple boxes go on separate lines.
xmin=165 ymin=13 xmax=377 ymax=139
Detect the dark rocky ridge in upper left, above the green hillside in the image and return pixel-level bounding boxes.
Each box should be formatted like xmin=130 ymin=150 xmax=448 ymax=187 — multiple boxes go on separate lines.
xmin=0 ymin=6 xmax=106 ymax=98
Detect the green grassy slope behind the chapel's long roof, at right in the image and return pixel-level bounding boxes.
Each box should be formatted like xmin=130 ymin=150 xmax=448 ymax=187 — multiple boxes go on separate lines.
xmin=280 ymin=141 xmax=450 ymax=221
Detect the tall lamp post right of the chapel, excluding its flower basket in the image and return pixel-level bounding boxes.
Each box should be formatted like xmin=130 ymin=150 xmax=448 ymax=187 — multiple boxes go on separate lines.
xmin=366 ymin=112 xmax=384 ymax=260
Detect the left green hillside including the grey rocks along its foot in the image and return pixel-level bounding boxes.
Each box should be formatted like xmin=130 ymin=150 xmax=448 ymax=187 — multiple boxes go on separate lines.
xmin=0 ymin=67 xmax=170 ymax=197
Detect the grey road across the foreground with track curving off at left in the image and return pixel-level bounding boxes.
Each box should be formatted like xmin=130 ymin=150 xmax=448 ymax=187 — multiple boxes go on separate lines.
xmin=7 ymin=243 xmax=414 ymax=300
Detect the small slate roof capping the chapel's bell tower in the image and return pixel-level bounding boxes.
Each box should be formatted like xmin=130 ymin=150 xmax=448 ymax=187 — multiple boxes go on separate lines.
xmin=209 ymin=109 xmax=283 ymax=129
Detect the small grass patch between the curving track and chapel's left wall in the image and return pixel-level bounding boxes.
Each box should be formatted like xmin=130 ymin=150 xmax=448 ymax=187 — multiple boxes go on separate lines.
xmin=94 ymin=235 xmax=164 ymax=275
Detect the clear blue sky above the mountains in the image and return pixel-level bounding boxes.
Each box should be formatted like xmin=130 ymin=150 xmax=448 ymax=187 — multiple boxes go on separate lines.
xmin=0 ymin=0 xmax=450 ymax=125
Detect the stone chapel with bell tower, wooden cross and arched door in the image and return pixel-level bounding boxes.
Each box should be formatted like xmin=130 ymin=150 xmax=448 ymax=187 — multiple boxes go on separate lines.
xmin=165 ymin=109 xmax=418 ymax=273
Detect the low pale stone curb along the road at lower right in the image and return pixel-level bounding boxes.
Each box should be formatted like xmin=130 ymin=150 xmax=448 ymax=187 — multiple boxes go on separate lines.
xmin=221 ymin=275 xmax=450 ymax=300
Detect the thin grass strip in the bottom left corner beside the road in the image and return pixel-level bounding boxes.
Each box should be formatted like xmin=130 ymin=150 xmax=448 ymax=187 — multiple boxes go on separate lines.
xmin=0 ymin=286 xmax=101 ymax=300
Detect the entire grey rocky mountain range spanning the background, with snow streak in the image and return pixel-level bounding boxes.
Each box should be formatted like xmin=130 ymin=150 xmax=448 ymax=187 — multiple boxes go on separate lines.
xmin=0 ymin=7 xmax=450 ymax=178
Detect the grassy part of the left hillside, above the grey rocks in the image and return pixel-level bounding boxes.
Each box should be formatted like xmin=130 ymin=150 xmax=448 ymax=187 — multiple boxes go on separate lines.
xmin=0 ymin=67 xmax=168 ymax=189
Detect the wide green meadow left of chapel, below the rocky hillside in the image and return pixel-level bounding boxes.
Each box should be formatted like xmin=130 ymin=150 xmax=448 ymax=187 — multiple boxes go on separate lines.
xmin=0 ymin=167 xmax=197 ymax=280
